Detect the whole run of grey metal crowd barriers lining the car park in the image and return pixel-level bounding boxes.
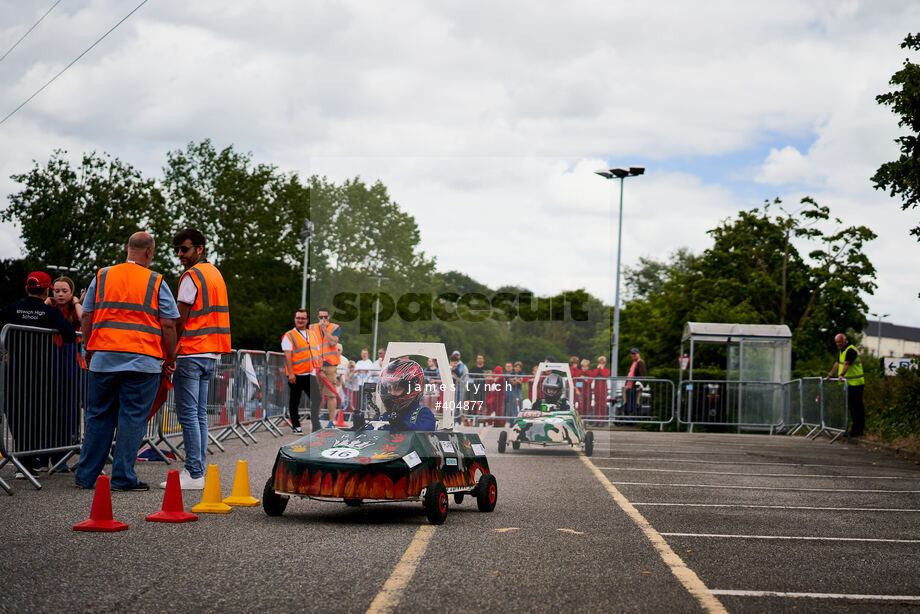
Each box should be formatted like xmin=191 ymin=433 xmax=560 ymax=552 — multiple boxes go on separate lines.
xmin=0 ymin=324 xmax=849 ymax=493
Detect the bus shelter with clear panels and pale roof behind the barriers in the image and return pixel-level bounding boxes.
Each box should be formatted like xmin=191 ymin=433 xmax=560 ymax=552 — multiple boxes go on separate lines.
xmin=677 ymin=322 xmax=792 ymax=432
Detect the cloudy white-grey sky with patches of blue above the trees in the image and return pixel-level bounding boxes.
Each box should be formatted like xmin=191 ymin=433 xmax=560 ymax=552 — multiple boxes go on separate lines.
xmin=0 ymin=0 xmax=920 ymax=326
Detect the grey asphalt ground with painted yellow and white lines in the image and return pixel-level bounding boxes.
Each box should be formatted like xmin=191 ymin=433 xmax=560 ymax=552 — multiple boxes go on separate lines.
xmin=0 ymin=429 xmax=920 ymax=612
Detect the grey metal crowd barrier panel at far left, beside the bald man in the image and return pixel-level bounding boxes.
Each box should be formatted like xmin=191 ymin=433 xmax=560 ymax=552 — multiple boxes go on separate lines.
xmin=0 ymin=324 xmax=87 ymax=488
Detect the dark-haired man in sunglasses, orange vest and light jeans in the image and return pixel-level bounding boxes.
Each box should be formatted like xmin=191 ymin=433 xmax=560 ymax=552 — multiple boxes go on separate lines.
xmin=160 ymin=228 xmax=230 ymax=490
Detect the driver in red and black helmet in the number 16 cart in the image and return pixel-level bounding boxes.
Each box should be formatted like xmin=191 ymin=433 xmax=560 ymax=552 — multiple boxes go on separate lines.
xmin=378 ymin=358 xmax=437 ymax=431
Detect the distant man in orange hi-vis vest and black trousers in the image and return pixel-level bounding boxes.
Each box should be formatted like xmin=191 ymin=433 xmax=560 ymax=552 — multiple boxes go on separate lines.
xmin=281 ymin=309 xmax=322 ymax=434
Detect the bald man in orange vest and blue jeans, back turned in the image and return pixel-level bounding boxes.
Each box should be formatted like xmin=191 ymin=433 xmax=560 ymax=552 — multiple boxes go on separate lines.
xmin=74 ymin=232 xmax=179 ymax=490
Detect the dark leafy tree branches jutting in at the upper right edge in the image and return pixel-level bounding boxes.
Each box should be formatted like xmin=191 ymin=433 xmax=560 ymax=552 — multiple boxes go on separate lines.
xmin=872 ymin=34 xmax=920 ymax=245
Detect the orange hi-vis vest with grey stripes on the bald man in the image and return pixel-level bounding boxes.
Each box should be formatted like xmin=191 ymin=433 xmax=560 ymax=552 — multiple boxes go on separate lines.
xmin=86 ymin=262 xmax=165 ymax=358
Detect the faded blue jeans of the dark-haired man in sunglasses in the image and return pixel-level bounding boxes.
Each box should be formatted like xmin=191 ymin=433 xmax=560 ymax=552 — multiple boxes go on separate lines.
xmin=173 ymin=356 xmax=217 ymax=478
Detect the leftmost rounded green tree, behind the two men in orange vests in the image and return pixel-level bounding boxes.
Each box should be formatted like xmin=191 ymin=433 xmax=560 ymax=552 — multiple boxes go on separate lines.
xmin=0 ymin=150 xmax=169 ymax=287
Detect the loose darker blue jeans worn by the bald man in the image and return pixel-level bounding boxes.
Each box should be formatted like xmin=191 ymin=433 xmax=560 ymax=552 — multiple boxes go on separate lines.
xmin=75 ymin=371 xmax=160 ymax=488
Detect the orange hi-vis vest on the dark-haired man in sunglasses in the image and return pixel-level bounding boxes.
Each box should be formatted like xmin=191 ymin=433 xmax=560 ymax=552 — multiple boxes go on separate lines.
xmin=179 ymin=262 xmax=230 ymax=356
